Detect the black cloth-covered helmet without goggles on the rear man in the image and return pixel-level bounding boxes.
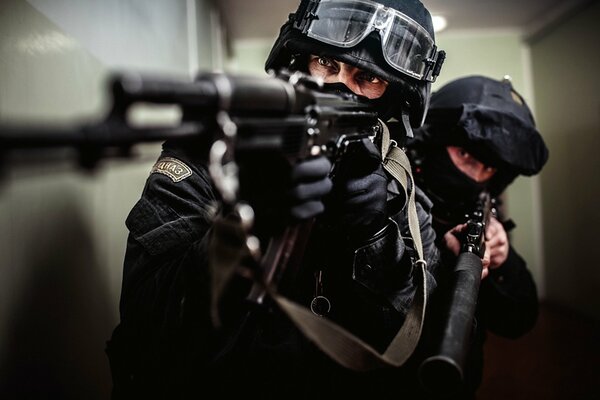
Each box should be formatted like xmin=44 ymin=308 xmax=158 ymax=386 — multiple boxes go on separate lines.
xmin=414 ymin=75 xmax=548 ymax=195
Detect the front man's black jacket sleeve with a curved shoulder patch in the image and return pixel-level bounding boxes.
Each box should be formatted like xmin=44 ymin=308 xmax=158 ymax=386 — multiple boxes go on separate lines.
xmin=120 ymin=145 xmax=218 ymax=359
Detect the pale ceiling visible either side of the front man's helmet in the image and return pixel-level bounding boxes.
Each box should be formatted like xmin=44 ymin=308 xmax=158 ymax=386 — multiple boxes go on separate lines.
xmin=217 ymin=0 xmax=593 ymax=40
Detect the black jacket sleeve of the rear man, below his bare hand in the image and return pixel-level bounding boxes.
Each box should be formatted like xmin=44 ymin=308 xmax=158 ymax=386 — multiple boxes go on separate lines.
xmin=478 ymin=246 xmax=538 ymax=338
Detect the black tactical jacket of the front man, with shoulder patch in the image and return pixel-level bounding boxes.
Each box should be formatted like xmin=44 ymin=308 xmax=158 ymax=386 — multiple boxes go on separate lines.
xmin=107 ymin=139 xmax=439 ymax=399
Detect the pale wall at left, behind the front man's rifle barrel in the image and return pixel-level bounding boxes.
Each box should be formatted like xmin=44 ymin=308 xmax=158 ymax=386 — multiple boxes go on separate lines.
xmin=0 ymin=0 xmax=222 ymax=399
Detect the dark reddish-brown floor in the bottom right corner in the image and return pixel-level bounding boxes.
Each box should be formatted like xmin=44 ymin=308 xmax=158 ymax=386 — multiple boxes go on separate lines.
xmin=477 ymin=304 xmax=600 ymax=400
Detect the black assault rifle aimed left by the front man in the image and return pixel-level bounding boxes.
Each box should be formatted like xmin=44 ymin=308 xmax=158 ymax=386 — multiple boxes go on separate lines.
xmin=0 ymin=71 xmax=380 ymax=303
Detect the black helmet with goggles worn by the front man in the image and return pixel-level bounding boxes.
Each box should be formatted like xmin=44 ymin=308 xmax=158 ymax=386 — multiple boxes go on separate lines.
xmin=265 ymin=0 xmax=445 ymax=127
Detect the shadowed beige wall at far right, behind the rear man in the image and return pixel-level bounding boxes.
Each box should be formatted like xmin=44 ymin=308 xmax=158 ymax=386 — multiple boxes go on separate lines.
xmin=531 ymin=1 xmax=600 ymax=320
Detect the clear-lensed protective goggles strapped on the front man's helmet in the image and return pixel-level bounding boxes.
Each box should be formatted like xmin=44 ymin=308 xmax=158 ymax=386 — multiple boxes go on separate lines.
xmin=294 ymin=0 xmax=445 ymax=82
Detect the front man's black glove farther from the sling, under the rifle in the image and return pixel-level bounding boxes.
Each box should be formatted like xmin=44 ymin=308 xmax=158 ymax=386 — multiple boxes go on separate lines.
xmin=238 ymin=153 xmax=332 ymax=237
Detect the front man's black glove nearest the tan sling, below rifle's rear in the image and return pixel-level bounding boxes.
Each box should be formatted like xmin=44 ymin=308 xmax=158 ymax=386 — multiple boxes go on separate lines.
xmin=325 ymin=139 xmax=388 ymax=242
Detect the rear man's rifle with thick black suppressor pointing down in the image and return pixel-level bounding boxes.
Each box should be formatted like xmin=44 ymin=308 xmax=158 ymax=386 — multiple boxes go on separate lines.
xmin=419 ymin=192 xmax=495 ymax=395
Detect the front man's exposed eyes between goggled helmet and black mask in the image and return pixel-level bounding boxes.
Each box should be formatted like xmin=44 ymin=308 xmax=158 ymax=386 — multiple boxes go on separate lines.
xmin=308 ymin=55 xmax=388 ymax=99
